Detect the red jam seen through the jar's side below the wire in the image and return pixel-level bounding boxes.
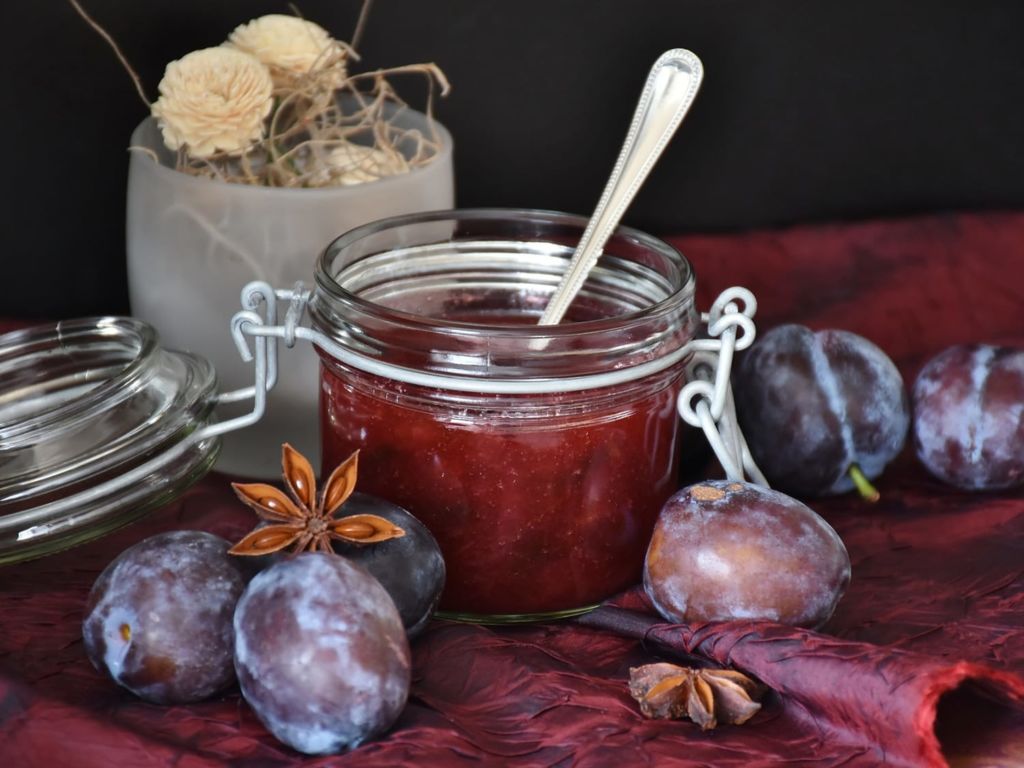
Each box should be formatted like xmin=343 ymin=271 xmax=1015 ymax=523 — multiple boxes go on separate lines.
xmin=321 ymin=314 xmax=682 ymax=615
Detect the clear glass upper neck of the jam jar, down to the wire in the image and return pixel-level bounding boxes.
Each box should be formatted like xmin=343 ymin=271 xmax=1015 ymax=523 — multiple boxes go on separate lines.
xmin=308 ymin=208 xmax=699 ymax=396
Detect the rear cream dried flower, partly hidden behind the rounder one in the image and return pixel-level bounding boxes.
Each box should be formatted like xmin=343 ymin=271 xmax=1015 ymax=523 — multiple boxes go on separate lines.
xmin=227 ymin=13 xmax=344 ymax=85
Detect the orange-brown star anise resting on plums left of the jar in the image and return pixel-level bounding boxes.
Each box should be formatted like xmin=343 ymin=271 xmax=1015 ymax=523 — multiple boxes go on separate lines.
xmin=228 ymin=442 xmax=406 ymax=555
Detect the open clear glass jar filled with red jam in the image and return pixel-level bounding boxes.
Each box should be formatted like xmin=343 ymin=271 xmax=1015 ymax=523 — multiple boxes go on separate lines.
xmin=309 ymin=210 xmax=699 ymax=621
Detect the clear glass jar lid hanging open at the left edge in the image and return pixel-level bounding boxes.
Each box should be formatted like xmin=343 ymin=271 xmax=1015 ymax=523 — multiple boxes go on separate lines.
xmin=0 ymin=317 xmax=220 ymax=564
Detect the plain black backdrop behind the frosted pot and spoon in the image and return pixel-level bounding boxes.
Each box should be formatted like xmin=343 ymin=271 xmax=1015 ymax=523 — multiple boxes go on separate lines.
xmin=6 ymin=0 xmax=1024 ymax=317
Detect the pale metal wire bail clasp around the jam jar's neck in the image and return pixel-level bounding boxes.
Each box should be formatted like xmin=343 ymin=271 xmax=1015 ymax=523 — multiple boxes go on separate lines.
xmin=224 ymin=281 xmax=768 ymax=485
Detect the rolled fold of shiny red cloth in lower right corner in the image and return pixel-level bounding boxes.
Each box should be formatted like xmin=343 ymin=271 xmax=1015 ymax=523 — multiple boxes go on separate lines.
xmin=577 ymin=606 xmax=1024 ymax=766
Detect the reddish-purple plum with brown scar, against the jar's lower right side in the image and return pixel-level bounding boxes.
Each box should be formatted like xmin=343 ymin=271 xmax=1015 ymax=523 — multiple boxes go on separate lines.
xmin=643 ymin=480 xmax=850 ymax=628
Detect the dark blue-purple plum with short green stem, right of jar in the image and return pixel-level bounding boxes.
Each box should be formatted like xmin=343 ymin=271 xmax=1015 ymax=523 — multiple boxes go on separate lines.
xmin=733 ymin=325 xmax=910 ymax=497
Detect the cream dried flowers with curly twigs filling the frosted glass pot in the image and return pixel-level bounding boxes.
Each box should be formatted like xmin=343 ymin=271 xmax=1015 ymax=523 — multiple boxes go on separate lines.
xmin=72 ymin=0 xmax=449 ymax=187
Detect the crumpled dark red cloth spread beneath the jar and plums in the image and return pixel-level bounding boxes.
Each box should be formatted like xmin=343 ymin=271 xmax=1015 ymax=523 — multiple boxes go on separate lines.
xmin=0 ymin=213 xmax=1024 ymax=768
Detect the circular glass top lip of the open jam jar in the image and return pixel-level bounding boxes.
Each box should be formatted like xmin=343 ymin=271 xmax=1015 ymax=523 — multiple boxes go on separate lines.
xmin=314 ymin=207 xmax=695 ymax=339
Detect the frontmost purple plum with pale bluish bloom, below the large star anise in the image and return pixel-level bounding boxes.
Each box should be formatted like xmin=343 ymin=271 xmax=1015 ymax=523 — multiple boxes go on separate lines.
xmin=234 ymin=552 xmax=412 ymax=755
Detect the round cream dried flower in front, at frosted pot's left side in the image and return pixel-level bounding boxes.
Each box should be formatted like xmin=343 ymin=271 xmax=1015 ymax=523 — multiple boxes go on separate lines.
xmin=152 ymin=48 xmax=273 ymax=158
